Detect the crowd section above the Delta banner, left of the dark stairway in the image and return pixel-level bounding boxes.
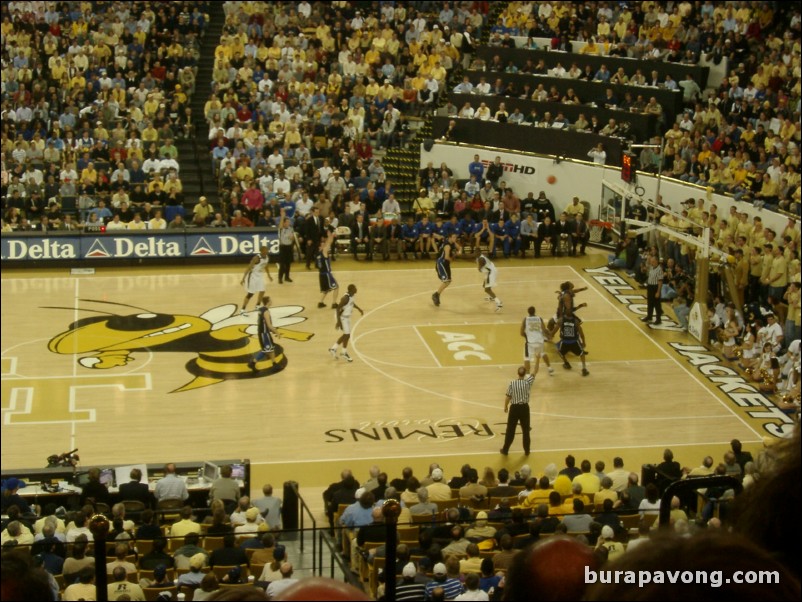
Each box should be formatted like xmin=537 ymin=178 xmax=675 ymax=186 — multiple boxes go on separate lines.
xmin=0 ymin=1 xmax=206 ymax=232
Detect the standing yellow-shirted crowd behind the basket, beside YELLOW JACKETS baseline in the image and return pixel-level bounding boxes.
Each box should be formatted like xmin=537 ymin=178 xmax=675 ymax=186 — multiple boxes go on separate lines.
xmin=608 ymin=191 xmax=802 ymax=408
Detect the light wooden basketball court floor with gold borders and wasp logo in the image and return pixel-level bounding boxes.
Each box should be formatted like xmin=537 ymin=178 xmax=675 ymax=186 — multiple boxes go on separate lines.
xmin=2 ymin=254 xmax=765 ymax=502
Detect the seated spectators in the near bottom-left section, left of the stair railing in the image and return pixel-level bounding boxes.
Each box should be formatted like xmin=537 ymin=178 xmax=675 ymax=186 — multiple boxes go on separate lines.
xmin=2 ymin=465 xmax=289 ymax=600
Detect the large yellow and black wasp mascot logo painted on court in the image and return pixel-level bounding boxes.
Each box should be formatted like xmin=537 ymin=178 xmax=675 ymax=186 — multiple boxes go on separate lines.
xmin=43 ymin=299 xmax=314 ymax=393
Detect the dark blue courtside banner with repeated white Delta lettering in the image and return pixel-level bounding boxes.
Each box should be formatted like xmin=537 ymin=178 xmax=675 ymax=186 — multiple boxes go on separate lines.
xmin=1 ymin=230 xmax=278 ymax=264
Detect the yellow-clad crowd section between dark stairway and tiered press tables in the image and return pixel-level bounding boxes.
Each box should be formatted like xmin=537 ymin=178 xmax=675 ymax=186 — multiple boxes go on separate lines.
xmin=198 ymin=2 xmax=486 ymax=232
